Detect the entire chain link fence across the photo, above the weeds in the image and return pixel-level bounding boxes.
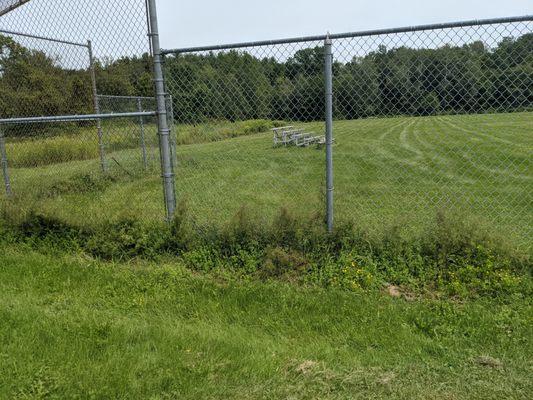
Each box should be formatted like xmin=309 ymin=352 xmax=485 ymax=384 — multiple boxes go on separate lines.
xmin=0 ymin=0 xmax=533 ymax=246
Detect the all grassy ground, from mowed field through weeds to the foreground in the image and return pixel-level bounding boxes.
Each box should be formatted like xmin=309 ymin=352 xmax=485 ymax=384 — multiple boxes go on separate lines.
xmin=0 ymin=113 xmax=533 ymax=400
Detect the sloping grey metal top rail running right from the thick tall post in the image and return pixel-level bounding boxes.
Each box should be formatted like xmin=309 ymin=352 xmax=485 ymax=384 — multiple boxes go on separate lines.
xmin=161 ymin=14 xmax=533 ymax=55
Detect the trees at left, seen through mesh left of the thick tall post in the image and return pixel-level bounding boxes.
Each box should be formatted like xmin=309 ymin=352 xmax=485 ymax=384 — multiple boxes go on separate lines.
xmin=0 ymin=35 xmax=153 ymax=118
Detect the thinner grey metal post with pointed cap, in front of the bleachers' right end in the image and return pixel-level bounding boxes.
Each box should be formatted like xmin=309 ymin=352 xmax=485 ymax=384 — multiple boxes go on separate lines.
xmin=324 ymin=35 xmax=333 ymax=232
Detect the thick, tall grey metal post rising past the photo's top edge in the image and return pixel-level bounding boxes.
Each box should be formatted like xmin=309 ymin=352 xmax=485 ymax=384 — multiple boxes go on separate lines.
xmin=147 ymin=0 xmax=176 ymax=221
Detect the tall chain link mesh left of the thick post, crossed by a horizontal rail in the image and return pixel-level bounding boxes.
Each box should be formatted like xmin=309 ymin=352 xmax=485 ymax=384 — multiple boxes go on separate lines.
xmin=0 ymin=0 xmax=164 ymax=224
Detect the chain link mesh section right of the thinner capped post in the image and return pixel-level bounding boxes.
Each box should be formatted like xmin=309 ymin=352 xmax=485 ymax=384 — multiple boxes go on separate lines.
xmin=334 ymin=21 xmax=533 ymax=245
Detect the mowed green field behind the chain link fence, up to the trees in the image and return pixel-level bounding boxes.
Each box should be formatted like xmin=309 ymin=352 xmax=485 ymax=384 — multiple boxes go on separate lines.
xmin=2 ymin=113 xmax=533 ymax=247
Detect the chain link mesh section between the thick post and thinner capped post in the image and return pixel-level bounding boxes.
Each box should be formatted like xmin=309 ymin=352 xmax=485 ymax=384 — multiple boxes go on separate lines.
xmin=165 ymin=41 xmax=324 ymax=227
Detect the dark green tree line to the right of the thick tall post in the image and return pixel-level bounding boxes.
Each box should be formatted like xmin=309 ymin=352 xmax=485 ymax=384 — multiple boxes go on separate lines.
xmin=166 ymin=34 xmax=533 ymax=122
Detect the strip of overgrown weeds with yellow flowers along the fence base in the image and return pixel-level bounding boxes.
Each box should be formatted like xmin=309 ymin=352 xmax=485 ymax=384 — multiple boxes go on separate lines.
xmin=3 ymin=202 xmax=532 ymax=298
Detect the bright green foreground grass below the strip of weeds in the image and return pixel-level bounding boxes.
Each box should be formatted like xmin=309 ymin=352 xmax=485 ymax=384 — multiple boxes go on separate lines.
xmin=0 ymin=244 xmax=533 ymax=399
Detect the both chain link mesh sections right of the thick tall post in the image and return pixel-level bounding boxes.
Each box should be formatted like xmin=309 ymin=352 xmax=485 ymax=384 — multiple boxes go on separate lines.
xmin=164 ymin=17 xmax=533 ymax=246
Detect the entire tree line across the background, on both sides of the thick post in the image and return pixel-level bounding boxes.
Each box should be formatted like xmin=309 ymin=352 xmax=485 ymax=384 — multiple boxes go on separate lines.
xmin=0 ymin=34 xmax=533 ymax=130
